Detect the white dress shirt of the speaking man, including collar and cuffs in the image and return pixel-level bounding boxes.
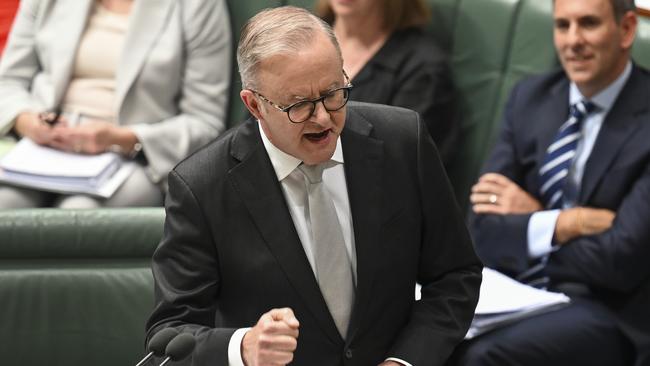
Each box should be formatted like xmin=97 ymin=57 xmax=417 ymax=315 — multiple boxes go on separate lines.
xmin=228 ymin=123 xmax=411 ymax=366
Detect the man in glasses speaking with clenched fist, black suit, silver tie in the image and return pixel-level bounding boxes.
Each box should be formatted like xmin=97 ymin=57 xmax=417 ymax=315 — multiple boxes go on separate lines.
xmin=147 ymin=7 xmax=481 ymax=366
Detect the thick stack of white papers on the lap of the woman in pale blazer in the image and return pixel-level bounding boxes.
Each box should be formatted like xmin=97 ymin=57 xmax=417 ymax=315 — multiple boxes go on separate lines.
xmin=0 ymin=138 xmax=135 ymax=198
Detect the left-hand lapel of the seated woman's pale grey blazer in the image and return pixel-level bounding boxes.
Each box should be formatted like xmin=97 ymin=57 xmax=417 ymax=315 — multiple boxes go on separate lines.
xmin=51 ymin=0 xmax=94 ymax=105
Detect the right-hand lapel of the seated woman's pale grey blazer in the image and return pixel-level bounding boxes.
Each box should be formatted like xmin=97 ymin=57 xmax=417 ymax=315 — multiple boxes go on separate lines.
xmin=116 ymin=0 xmax=173 ymax=110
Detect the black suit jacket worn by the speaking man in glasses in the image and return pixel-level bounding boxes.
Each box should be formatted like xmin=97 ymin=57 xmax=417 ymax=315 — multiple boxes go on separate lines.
xmin=148 ymin=103 xmax=481 ymax=366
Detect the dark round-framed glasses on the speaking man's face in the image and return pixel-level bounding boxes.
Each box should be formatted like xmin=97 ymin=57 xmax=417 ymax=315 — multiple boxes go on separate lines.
xmin=249 ymin=71 xmax=352 ymax=123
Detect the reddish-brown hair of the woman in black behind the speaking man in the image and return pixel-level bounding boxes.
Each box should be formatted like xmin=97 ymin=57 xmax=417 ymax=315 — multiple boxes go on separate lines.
xmin=316 ymin=0 xmax=431 ymax=32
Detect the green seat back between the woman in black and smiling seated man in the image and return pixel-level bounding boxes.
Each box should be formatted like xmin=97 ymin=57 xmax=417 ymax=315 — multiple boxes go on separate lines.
xmin=442 ymin=0 xmax=557 ymax=209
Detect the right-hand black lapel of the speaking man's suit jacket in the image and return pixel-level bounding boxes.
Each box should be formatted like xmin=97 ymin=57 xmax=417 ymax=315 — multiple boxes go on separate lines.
xmin=341 ymin=108 xmax=383 ymax=343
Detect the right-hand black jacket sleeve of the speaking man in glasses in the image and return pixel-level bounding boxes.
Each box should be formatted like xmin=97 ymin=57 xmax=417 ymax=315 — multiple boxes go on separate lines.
xmin=388 ymin=113 xmax=482 ymax=365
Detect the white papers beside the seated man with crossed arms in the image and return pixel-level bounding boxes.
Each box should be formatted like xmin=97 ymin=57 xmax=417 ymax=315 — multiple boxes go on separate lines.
xmin=465 ymin=268 xmax=571 ymax=339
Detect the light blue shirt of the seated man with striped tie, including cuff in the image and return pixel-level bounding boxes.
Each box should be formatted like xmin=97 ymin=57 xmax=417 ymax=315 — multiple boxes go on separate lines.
xmin=527 ymin=61 xmax=632 ymax=258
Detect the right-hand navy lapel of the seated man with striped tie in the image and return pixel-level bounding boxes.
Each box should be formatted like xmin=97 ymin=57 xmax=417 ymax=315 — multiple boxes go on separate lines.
xmin=579 ymin=67 xmax=650 ymax=203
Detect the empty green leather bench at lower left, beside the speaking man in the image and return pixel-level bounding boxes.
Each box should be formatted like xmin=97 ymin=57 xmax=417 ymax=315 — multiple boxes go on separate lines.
xmin=0 ymin=208 xmax=164 ymax=366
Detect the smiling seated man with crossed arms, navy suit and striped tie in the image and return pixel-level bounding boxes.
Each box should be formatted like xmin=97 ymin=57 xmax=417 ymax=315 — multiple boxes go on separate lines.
xmin=450 ymin=0 xmax=650 ymax=366
